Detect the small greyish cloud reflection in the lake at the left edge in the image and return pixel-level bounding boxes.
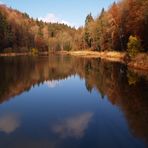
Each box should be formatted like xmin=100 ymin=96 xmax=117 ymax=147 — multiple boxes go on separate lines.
xmin=0 ymin=113 xmax=20 ymax=134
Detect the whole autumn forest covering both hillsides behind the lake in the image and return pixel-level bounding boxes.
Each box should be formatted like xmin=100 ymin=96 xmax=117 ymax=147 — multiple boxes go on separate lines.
xmin=0 ymin=0 xmax=148 ymax=53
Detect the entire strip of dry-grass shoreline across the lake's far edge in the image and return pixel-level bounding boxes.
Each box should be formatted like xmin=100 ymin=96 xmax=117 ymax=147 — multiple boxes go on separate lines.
xmin=0 ymin=50 xmax=148 ymax=71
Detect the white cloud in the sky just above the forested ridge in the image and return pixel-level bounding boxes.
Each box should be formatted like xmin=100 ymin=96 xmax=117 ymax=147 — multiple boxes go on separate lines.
xmin=39 ymin=13 xmax=73 ymax=27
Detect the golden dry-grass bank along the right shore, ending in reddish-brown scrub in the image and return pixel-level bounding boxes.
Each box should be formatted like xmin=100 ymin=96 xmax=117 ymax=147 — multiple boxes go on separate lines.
xmin=59 ymin=51 xmax=148 ymax=71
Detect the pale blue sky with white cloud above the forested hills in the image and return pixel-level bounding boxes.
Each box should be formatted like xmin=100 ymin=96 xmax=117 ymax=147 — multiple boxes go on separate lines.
xmin=0 ymin=0 xmax=117 ymax=27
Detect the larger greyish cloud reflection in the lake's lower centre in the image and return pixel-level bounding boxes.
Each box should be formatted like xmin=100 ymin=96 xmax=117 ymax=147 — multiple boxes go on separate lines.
xmin=52 ymin=112 xmax=93 ymax=138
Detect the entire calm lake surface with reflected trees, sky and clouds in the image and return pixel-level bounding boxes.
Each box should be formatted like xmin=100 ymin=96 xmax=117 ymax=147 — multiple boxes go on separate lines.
xmin=0 ymin=56 xmax=148 ymax=148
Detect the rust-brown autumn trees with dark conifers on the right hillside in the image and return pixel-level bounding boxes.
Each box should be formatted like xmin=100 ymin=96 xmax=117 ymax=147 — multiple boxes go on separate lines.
xmin=83 ymin=0 xmax=148 ymax=51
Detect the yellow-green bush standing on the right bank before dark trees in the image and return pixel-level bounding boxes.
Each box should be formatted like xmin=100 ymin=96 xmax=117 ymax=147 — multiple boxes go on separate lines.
xmin=128 ymin=36 xmax=142 ymax=57
